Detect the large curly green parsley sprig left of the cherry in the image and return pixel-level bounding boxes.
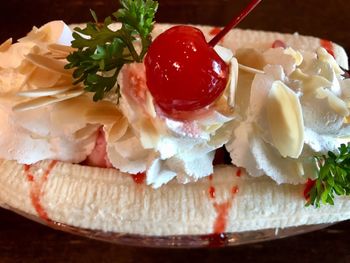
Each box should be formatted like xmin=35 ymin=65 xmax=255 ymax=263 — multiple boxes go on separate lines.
xmin=65 ymin=0 xmax=158 ymax=101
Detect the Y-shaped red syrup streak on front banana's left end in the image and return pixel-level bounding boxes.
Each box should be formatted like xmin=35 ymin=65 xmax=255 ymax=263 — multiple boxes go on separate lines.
xmin=24 ymin=161 xmax=57 ymax=222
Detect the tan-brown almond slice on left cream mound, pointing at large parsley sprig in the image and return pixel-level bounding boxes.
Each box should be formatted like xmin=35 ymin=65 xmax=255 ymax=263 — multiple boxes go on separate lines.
xmin=26 ymin=54 xmax=72 ymax=75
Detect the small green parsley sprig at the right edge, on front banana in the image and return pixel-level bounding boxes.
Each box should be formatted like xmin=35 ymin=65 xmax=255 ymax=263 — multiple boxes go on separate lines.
xmin=306 ymin=144 xmax=350 ymax=207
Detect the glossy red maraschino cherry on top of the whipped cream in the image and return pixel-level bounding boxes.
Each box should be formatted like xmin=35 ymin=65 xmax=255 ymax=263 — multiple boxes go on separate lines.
xmin=145 ymin=26 xmax=229 ymax=114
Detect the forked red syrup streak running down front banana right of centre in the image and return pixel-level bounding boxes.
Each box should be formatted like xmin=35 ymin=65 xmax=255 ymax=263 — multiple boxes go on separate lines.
xmin=204 ymin=175 xmax=238 ymax=247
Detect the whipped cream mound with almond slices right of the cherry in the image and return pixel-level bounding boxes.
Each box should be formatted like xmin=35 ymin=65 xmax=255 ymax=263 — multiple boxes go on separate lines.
xmin=226 ymin=45 xmax=350 ymax=184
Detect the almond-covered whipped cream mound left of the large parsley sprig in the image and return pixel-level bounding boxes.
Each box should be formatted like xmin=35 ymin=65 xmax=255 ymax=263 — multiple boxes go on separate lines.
xmin=0 ymin=21 xmax=98 ymax=164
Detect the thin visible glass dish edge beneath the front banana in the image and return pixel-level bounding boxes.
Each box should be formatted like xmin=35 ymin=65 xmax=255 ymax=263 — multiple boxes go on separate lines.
xmin=7 ymin=207 xmax=333 ymax=248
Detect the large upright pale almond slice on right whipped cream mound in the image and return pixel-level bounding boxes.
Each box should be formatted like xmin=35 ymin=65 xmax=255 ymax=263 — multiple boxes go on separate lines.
xmin=266 ymin=81 xmax=304 ymax=158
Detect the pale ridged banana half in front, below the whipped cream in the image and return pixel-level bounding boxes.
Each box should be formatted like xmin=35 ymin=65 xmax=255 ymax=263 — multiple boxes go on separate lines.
xmin=0 ymin=160 xmax=350 ymax=236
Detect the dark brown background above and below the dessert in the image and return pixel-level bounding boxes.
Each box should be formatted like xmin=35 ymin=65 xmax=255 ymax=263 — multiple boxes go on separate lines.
xmin=0 ymin=0 xmax=350 ymax=263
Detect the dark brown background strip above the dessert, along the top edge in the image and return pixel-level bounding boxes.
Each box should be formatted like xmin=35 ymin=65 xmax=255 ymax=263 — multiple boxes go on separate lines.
xmin=0 ymin=0 xmax=350 ymax=49
